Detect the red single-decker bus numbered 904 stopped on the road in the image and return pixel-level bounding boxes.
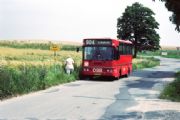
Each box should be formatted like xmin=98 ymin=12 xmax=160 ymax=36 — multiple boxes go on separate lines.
xmin=80 ymin=38 xmax=133 ymax=79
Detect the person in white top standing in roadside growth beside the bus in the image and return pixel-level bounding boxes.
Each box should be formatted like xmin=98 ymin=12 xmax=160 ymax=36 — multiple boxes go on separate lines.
xmin=65 ymin=56 xmax=74 ymax=74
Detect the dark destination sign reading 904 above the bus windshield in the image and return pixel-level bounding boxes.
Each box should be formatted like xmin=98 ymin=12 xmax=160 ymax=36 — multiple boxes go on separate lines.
xmin=85 ymin=39 xmax=112 ymax=45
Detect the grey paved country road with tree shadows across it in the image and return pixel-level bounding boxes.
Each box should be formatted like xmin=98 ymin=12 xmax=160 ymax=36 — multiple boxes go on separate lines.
xmin=0 ymin=58 xmax=180 ymax=120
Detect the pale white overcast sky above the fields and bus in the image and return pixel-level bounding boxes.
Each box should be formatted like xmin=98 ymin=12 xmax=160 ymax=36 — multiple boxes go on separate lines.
xmin=0 ymin=0 xmax=180 ymax=46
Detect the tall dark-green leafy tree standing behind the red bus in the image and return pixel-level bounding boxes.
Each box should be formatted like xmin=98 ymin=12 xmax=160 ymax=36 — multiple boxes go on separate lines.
xmin=117 ymin=2 xmax=160 ymax=57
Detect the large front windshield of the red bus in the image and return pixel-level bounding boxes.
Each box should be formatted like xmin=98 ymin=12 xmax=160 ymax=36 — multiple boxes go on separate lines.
xmin=84 ymin=46 xmax=114 ymax=60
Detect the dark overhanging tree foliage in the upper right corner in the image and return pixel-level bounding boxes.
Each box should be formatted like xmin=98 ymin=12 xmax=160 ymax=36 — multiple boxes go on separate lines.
xmin=153 ymin=0 xmax=180 ymax=32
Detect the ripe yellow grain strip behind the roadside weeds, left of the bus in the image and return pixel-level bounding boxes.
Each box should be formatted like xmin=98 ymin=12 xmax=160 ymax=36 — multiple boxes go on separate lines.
xmin=0 ymin=47 xmax=82 ymax=65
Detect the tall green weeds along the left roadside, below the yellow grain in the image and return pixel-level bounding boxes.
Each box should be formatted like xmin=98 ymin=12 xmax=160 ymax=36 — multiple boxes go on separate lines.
xmin=0 ymin=64 xmax=79 ymax=99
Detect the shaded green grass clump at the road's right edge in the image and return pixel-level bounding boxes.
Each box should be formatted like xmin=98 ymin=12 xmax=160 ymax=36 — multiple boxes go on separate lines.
xmin=160 ymin=71 xmax=180 ymax=102
